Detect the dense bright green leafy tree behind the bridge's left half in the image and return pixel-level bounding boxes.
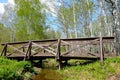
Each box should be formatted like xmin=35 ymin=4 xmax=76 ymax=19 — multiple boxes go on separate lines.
xmin=15 ymin=0 xmax=46 ymax=41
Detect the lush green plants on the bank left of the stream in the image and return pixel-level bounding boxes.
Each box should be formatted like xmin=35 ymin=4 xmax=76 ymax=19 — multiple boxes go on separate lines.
xmin=0 ymin=57 xmax=33 ymax=80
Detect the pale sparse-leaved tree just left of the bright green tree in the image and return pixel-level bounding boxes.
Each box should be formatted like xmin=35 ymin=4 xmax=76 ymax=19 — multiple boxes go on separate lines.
xmin=2 ymin=4 xmax=15 ymax=42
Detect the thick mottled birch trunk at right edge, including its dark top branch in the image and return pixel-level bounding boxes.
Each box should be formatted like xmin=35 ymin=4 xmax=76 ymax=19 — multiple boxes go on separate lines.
xmin=106 ymin=0 xmax=120 ymax=55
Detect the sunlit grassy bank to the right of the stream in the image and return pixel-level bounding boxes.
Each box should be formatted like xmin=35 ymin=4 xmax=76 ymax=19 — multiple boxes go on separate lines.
xmin=58 ymin=57 xmax=120 ymax=80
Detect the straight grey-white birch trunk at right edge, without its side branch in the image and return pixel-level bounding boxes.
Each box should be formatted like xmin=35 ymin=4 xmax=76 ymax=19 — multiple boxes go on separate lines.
xmin=113 ymin=0 xmax=120 ymax=55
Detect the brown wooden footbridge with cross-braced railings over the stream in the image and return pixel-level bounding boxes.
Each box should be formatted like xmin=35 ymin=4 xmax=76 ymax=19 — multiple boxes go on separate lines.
xmin=1 ymin=37 xmax=115 ymax=68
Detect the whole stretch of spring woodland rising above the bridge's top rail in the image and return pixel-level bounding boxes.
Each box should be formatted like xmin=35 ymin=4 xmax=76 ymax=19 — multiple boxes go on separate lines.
xmin=0 ymin=0 xmax=120 ymax=53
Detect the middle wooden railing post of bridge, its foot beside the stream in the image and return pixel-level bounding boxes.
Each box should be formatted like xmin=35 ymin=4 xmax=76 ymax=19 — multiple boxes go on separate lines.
xmin=56 ymin=39 xmax=62 ymax=70
